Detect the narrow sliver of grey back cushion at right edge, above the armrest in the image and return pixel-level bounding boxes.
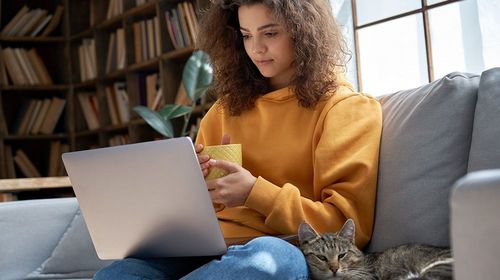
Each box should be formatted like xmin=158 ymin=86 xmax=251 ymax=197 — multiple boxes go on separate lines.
xmin=469 ymin=68 xmax=500 ymax=171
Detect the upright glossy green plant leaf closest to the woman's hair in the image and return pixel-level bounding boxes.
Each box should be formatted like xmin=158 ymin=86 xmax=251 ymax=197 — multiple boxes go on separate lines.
xmin=182 ymin=51 xmax=213 ymax=102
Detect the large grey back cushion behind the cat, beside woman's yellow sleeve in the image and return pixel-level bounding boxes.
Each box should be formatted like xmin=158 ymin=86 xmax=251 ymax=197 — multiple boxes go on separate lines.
xmin=368 ymin=73 xmax=479 ymax=251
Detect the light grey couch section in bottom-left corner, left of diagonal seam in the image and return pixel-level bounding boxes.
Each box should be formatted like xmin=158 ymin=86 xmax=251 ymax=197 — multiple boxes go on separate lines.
xmin=0 ymin=198 xmax=78 ymax=279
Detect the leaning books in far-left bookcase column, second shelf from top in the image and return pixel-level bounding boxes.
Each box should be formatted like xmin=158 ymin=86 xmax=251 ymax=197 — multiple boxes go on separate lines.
xmin=0 ymin=48 xmax=53 ymax=85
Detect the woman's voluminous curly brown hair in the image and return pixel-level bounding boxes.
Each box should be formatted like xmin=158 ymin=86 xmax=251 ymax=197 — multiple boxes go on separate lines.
xmin=197 ymin=0 xmax=348 ymax=115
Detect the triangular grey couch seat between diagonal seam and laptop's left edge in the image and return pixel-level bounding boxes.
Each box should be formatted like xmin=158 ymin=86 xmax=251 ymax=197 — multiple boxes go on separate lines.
xmin=26 ymin=210 xmax=111 ymax=279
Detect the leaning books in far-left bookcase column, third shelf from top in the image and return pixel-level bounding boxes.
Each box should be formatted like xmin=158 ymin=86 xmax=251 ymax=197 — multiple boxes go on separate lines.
xmin=12 ymin=97 xmax=66 ymax=135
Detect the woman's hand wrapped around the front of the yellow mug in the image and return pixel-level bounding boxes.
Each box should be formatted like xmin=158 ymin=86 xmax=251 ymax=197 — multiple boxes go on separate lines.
xmin=207 ymin=159 xmax=257 ymax=207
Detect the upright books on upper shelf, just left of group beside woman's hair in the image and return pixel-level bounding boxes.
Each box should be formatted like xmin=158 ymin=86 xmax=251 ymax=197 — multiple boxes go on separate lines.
xmin=132 ymin=17 xmax=161 ymax=63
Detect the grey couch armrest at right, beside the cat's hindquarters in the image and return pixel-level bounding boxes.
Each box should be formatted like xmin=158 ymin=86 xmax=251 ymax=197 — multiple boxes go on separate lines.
xmin=451 ymin=169 xmax=500 ymax=280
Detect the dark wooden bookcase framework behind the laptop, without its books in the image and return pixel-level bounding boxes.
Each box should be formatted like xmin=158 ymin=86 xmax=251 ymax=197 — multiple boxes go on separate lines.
xmin=0 ymin=0 xmax=211 ymax=197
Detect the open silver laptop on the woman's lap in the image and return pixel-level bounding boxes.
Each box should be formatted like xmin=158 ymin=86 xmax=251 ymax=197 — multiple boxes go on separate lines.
xmin=62 ymin=137 xmax=227 ymax=260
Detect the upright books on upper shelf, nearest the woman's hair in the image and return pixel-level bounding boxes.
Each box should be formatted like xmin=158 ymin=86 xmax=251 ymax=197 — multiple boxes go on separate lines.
xmin=165 ymin=2 xmax=198 ymax=49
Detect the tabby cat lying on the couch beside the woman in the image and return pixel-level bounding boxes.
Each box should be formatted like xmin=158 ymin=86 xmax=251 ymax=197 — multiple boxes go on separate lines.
xmin=298 ymin=219 xmax=453 ymax=280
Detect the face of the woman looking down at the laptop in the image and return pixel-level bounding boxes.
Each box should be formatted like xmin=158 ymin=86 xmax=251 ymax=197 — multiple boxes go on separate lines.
xmin=238 ymin=4 xmax=295 ymax=89
